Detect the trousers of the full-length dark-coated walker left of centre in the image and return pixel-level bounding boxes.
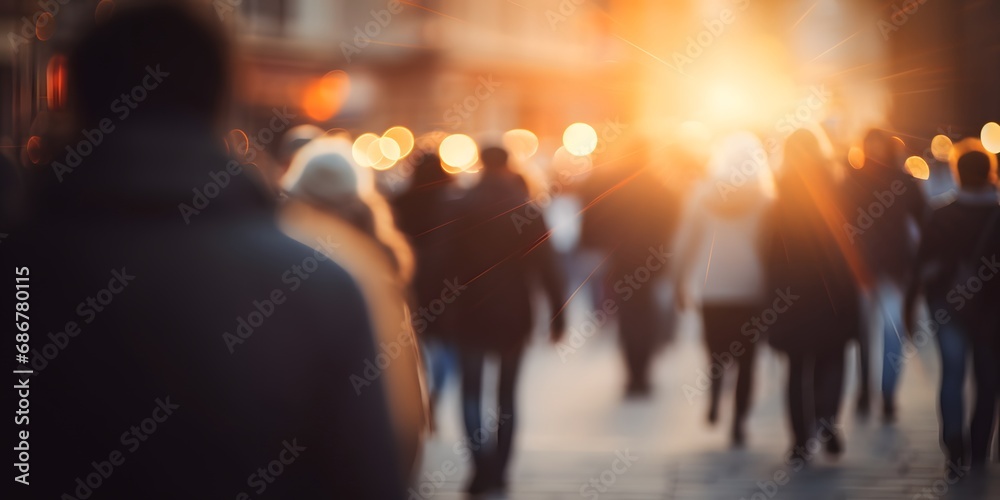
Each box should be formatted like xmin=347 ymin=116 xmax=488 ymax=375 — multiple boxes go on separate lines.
xmin=460 ymin=349 xmax=522 ymax=480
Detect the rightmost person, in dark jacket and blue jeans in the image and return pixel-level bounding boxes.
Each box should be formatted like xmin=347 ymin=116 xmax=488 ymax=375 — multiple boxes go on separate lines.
xmin=905 ymin=139 xmax=1000 ymax=474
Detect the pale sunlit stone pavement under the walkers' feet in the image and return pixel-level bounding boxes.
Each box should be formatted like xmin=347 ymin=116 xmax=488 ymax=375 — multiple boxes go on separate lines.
xmin=410 ymin=315 xmax=1000 ymax=500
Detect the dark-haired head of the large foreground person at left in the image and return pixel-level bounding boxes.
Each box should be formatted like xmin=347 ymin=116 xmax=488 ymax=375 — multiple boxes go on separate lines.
xmin=68 ymin=1 xmax=229 ymax=124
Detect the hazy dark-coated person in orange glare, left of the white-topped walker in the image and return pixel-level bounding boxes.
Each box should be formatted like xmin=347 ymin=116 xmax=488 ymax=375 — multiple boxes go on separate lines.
xmin=583 ymin=140 xmax=680 ymax=397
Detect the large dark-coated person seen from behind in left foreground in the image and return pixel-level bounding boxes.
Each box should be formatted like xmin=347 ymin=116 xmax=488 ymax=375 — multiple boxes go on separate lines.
xmin=4 ymin=3 xmax=405 ymax=499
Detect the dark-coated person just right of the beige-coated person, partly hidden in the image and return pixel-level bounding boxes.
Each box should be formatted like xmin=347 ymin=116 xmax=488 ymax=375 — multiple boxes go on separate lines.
xmin=392 ymin=153 xmax=462 ymax=409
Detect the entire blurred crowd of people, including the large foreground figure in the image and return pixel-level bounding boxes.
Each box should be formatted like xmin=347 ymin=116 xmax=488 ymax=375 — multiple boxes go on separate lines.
xmin=5 ymin=1 xmax=1000 ymax=498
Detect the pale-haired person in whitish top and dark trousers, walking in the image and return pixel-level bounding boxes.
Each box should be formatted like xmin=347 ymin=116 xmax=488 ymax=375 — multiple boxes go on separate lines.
xmin=675 ymin=132 xmax=774 ymax=446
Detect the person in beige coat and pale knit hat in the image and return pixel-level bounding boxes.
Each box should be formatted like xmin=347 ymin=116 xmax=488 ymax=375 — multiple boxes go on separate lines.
xmin=279 ymin=138 xmax=427 ymax=481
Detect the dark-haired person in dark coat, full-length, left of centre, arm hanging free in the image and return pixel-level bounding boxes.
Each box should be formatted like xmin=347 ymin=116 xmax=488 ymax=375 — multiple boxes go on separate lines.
xmin=455 ymin=147 xmax=565 ymax=493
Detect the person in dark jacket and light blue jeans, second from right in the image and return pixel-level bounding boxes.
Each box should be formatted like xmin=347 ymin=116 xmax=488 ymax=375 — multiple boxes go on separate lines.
xmin=847 ymin=129 xmax=928 ymax=423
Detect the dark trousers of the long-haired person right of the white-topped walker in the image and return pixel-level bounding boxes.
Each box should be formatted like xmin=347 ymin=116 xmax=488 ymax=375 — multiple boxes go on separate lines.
xmin=788 ymin=348 xmax=844 ymax=448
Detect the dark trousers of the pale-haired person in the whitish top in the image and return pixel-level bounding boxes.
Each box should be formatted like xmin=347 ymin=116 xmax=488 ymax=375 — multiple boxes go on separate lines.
xmin=702 ymin=303 xmax=760 ymax=428
